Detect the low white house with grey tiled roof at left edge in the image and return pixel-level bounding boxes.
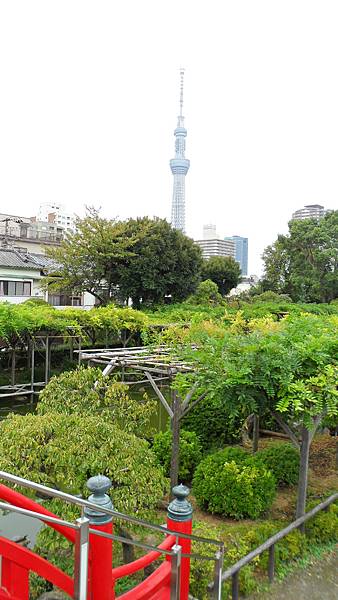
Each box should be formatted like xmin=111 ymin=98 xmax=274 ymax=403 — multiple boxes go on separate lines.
xmin=0 ymin=248 xmax=95 ymax=308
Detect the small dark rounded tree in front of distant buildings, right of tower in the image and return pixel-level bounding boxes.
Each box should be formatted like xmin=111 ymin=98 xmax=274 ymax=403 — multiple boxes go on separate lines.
xmin=202 ymin=256 xmax=241 ymax=296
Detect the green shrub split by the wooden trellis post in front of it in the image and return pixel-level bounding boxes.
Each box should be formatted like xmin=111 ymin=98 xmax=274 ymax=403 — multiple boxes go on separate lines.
xmin=152 ymin=429 xmax=202 ymax=481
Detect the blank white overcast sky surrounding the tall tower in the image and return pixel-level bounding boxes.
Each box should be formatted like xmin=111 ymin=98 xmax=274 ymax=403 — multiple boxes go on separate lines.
xmin=0 ymin=0 xmax=338 ymax=273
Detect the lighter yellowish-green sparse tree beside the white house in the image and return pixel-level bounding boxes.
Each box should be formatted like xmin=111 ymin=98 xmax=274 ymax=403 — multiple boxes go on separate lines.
xmin=43 ymin=208 xmax=136 ymax=305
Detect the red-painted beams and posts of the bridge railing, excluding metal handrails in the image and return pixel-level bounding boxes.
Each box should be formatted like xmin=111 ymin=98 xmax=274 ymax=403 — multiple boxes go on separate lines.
xmin=0 ymin=476 xmax=192 ymax=600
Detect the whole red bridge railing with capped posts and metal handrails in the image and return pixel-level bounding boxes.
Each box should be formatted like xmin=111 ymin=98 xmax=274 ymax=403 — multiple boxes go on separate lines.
xmin=0 ymin=471 xmax=223 ymax=600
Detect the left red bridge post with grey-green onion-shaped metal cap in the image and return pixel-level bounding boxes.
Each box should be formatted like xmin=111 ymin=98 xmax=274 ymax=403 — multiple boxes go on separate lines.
xmin=84 ymin=475 xmax=115 ymax=600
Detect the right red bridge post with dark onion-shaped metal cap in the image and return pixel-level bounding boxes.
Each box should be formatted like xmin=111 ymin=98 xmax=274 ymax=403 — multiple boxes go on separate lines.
xmin=167 ymin=484 xmax=192 ymax=600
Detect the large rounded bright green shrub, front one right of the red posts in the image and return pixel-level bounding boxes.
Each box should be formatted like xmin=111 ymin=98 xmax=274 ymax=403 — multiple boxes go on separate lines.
xmin=193 ymin=449 xmax=276 ymax=519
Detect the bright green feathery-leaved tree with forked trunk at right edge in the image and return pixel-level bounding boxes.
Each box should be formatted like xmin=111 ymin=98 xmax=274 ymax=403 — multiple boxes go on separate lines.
xmin=181 ymin=315 xmax=338 ymax=516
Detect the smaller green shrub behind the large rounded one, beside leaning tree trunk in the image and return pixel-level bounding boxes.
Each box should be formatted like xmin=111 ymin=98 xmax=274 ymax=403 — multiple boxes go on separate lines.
xmin=254 ymin=442 xmax=299 ymax=485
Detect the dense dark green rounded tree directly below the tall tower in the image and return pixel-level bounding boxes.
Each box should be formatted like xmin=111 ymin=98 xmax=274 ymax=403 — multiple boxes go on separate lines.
xmin=119 ymin=217 xmax=202 ymax=308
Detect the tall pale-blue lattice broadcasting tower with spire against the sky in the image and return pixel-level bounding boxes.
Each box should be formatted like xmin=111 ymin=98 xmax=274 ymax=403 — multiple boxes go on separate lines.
xmin=170 ymin=69 xmax=190 ymax=232
